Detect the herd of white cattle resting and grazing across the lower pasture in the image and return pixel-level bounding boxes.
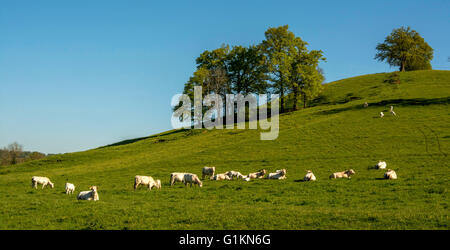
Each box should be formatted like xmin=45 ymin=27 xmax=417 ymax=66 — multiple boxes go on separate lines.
xmin=31 ymin=161 xmax=397 ymax=201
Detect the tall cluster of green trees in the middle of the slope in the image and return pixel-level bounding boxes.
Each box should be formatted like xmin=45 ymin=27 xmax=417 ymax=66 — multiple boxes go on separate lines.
xmin=180 ymin=25 xmax=325 ymax=112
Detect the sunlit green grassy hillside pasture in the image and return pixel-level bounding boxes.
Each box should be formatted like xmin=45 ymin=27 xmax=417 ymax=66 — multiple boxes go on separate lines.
xmin=0 ymin=71 xmax=450 ymax=229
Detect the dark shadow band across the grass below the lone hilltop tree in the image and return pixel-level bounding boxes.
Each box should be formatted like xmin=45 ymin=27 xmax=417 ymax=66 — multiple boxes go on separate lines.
xmin=317 ymin=97 xmax=450 ymax=115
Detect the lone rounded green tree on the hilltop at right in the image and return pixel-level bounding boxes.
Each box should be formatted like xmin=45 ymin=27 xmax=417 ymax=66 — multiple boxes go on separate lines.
xmin=375 ymin=27 xmax=433 ymax=71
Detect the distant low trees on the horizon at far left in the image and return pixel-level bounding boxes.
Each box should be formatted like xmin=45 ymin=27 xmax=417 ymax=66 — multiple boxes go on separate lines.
xmin=0 ymin=142 xmax=46 ymax=166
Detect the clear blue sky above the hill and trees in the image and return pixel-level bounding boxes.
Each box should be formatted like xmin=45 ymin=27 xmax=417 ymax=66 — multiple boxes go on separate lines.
xmin=0 ymin=0 xmax=450 ymax=153
